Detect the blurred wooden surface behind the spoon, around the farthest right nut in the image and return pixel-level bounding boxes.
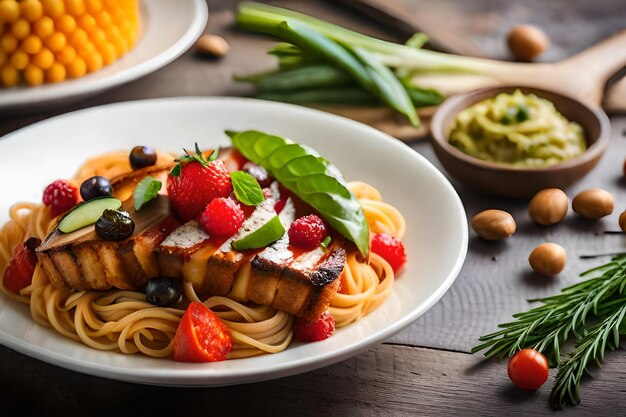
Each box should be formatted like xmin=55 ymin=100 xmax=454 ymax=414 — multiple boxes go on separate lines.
xmin=340 ymin=0 xmax=626 ymax=62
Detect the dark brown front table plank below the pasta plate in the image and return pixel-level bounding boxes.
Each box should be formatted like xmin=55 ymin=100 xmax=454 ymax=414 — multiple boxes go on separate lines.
xmin=0 ymin=344 xmax=626 ymax=417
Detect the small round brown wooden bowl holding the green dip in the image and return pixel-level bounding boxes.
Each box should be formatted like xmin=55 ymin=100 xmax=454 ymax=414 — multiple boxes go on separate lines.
xmin=431 ymin=87 xmax=610 ymax=198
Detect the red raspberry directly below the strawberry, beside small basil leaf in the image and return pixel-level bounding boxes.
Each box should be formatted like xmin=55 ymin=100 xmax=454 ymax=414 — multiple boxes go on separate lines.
xmin=200 ymin=197 xmax=244 ymax=237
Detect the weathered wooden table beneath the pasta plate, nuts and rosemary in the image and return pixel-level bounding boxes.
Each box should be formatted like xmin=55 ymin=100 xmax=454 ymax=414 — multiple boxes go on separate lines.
xmin=0 ymin=1 xmax=626 ymax=416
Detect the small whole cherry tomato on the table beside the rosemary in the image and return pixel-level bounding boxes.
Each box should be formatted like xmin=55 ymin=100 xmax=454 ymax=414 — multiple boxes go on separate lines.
xmin=507 ymin=349 xmax=549 ymax=390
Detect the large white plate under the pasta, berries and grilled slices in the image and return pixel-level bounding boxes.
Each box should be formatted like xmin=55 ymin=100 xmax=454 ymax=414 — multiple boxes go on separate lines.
xmin=0 ymin=98 xmax=467 ymax=386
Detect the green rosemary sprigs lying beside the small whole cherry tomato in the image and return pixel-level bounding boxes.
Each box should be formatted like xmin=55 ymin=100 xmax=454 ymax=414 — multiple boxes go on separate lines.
xmin=472 ymin=255 xmax=626 ymax=408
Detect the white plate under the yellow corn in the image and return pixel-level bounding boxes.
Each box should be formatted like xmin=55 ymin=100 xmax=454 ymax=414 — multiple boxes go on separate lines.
xmin=0 ymin=0 xmax=208 ymax=112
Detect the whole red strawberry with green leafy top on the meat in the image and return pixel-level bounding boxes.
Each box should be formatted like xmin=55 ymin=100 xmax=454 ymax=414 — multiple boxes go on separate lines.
xmin=167 ymin=144 xmax=232 ymax=222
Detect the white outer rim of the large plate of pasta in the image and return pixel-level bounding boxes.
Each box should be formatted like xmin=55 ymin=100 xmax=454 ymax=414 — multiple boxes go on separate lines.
xmin=0 ymin=96 xmax=469 ymax=387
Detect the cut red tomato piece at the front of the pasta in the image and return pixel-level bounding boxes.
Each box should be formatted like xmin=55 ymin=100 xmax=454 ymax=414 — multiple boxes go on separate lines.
xmin=174 ymin=302 xmax=233 ymax=362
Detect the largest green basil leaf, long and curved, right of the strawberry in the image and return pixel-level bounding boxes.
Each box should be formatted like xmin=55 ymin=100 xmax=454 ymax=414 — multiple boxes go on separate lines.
xmin=227 ymin=130 xmax=369 ymax=256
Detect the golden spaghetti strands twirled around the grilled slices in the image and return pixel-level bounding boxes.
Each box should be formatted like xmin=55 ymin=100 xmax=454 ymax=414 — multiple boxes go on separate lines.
xmin=0 ymin=152 xmax=406 ymax=358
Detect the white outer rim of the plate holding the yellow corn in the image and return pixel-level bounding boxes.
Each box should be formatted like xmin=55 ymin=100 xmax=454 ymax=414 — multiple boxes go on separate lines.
xmin=0 ymin=0 xmax=209 ymax=111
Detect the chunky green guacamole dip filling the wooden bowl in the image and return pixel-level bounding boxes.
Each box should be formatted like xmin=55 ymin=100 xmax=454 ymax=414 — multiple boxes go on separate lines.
xmin=448 ymin=90 xmax=587 ymax=168
